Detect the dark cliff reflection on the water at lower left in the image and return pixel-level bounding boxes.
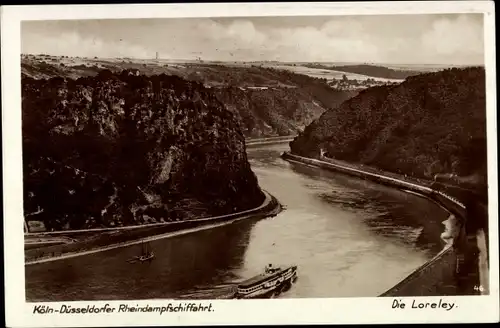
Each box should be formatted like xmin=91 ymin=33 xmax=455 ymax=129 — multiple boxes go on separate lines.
xmin=26 ymin=221 xmax=254 ymax=301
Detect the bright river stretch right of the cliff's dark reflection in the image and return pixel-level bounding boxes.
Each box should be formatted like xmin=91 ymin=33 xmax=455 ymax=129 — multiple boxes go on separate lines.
xmin=243 ymin=145 xmax=447 ymax=297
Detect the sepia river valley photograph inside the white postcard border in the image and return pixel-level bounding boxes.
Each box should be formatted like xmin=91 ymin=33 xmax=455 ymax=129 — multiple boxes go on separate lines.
xmin=2 ymin=1 xmax=498 ymax=326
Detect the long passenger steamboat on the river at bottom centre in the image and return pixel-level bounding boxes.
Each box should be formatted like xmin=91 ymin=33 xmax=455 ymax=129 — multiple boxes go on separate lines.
xmin=235 ymin=264 xmax=297 ymax=299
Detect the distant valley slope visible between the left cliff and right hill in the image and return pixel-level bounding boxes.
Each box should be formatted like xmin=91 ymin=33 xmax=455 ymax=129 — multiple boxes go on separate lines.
xmin=189 ymin=65 xmax=356 ymax=137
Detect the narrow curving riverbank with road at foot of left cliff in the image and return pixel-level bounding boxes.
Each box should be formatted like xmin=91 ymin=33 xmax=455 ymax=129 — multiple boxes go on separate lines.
xmin=25 ymin=190 xmax=282 ymax=265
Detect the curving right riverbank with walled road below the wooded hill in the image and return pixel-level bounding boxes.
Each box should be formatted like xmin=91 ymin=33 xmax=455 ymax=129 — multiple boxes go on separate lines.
xmin=282 ymin=152 xmax=489 ymax=297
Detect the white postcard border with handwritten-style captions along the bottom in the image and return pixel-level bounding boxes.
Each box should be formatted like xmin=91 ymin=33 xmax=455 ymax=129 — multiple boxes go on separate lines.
xmin=1 ymin=1 xmax=499 ymax=327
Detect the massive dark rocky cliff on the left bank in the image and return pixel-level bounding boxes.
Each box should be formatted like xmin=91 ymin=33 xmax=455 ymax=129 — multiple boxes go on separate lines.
xmin=22 ymin=71 xmax=264 ymax=230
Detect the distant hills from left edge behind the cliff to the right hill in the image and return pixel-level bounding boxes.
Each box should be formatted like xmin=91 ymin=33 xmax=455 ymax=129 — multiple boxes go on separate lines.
xmin=22 ymin=55 xmax=357 ymax=137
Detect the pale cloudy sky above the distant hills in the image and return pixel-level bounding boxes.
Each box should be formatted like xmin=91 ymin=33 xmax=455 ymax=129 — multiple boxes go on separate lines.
xmin=21 ymin=14 xmax=484 ymax=65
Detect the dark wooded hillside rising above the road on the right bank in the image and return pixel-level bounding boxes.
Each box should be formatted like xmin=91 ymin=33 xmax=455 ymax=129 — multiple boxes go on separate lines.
xmin=291 ymin=68 xmax=487 ymax=195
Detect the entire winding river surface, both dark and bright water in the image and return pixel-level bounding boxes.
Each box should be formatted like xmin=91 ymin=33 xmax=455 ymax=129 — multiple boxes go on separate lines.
xmin=26 ymin=144 xmax=447 ymax=301
